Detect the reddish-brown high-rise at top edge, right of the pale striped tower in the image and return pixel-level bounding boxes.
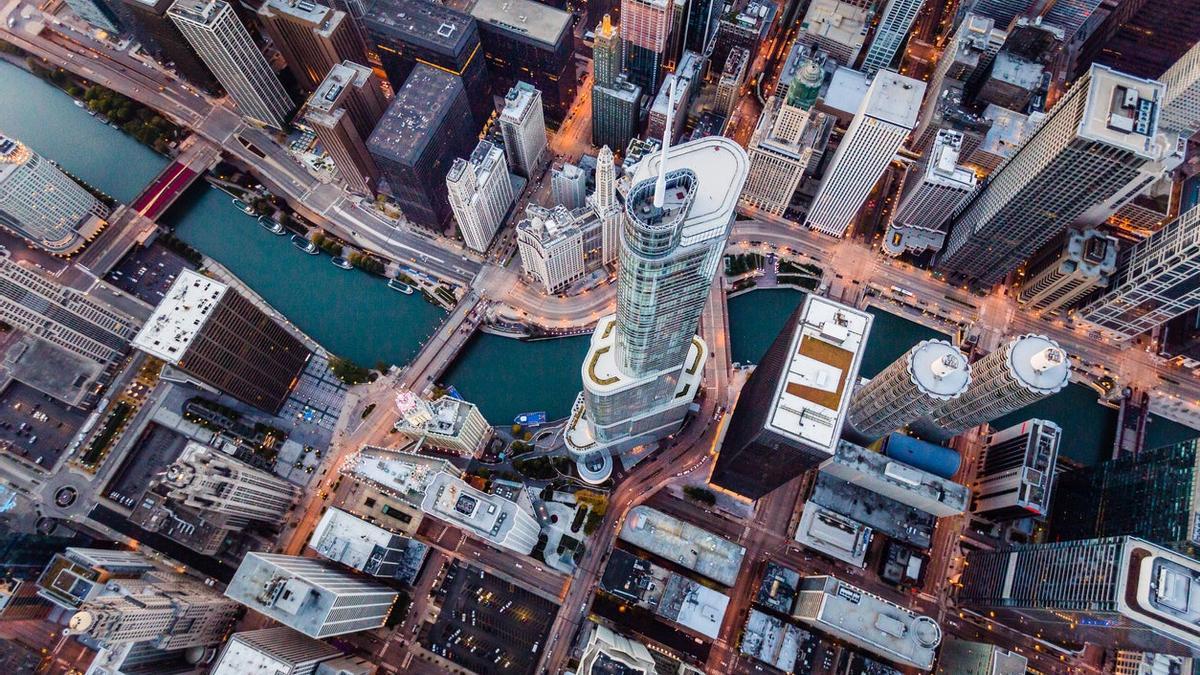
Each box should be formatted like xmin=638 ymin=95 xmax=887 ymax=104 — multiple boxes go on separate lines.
xmin=258 ymin=0 xmax=367 ymax=91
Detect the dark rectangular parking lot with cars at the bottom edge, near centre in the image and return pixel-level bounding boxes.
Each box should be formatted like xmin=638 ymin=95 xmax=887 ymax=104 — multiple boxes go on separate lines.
xmin=421 ymin=563 xmax=558 ymax=674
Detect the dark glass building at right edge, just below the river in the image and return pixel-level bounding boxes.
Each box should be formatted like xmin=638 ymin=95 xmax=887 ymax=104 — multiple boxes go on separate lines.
xmin=1049 ymin=441 xmax=1200 ymax=551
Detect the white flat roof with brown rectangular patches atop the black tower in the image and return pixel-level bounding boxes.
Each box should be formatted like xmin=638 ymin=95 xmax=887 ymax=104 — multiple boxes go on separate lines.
xmin=767 ymin=294 xmax=872 ymax=455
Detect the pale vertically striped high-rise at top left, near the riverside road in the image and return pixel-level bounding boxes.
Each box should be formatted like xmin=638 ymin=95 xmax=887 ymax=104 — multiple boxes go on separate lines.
xmin=167 ymin=0 xmax=295 ymax=129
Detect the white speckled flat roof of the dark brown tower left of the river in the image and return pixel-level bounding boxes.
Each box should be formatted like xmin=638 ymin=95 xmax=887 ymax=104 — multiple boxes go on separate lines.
xmin=133 ymin=269 xmax=229 ymax=365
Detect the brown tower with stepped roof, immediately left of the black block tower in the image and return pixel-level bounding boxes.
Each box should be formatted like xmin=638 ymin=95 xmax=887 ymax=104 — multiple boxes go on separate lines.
xmin=304 ymin=60 xmax=388 ymax=195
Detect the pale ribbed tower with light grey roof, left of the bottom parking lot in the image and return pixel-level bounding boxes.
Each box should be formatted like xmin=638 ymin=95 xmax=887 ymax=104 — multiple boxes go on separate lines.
xmin=226 ymin=552 xmax=396 ymax=639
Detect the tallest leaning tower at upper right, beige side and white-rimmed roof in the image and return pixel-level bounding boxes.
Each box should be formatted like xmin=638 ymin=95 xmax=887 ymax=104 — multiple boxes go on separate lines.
xmin=937 ymin=66 xmax=1174 ymax=286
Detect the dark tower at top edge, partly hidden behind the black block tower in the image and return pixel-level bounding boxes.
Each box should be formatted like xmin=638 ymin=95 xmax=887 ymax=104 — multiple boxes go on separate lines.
xmin=361 ymin=0 xmax=496 ymax=125
